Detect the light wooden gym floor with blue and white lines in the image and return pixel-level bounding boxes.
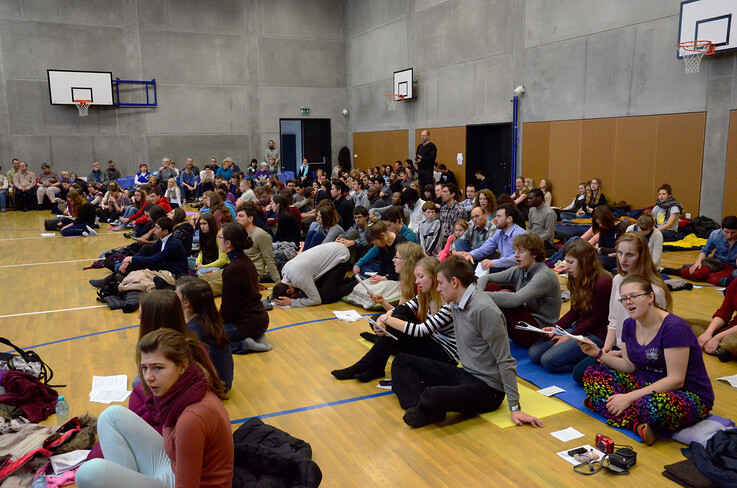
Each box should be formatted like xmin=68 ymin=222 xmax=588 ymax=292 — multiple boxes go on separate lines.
xmin=0 ymin=211 xmax=737 ymax=487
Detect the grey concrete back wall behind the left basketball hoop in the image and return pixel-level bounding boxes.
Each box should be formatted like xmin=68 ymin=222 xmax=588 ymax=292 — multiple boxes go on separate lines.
xmin=0 ymin=0 xmax=348 ymax=175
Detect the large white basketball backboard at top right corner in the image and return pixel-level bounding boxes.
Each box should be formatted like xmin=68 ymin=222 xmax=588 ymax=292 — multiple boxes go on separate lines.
xmin=677 ymin=0 xmax=737 ymax=59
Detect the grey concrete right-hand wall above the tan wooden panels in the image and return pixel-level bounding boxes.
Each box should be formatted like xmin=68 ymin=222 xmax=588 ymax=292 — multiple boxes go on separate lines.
xmin=346 ymin=0 xmax=737 ymax=218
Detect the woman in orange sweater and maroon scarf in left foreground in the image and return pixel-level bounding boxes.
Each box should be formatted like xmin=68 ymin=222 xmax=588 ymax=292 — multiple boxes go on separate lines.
xmin=76 ymin=328 xmax=233 ymax=488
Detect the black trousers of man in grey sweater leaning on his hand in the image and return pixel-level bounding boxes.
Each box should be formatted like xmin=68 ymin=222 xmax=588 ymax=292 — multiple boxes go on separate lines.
xmin=392 ymin=354 xmax=504 ymax=418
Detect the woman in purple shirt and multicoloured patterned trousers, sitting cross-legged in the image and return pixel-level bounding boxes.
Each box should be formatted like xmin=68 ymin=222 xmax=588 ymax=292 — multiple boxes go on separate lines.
xmin=581 ymin=275 xmax=714 ymax=444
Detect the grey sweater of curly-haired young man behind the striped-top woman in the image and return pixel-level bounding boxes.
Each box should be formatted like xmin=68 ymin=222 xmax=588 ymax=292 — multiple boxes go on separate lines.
xmin=478 ymin=263 xmax=562 ymax=327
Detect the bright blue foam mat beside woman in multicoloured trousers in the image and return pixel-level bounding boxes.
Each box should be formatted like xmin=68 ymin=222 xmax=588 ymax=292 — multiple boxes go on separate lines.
xmin=509 ymin=341 xmax=642 ymax=442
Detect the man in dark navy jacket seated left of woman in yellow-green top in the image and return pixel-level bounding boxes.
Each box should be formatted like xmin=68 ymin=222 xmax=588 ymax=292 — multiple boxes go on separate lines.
xmin=120 ymin=217 xmax=187 ymax=277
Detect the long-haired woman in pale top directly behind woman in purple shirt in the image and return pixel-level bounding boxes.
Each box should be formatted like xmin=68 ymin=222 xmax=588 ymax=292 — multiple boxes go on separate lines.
xmin=573 ymin=233 xmax=673 ymax=385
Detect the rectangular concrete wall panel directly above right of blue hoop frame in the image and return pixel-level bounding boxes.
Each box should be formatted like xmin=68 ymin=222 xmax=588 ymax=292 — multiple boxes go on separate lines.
xmin=141 ymin=31 xmax=247 ymax=85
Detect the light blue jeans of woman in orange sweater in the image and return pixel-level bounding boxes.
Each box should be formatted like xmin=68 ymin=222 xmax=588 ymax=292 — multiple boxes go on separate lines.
xmin=76 ymin=405 xmax=174 ymax=488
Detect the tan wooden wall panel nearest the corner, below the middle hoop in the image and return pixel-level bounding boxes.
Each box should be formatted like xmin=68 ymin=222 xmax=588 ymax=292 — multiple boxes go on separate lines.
xmin=353 ymin=129 xmax=409 ymax=170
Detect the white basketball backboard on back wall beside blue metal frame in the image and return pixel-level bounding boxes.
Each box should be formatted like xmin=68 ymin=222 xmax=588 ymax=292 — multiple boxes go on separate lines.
xmin=46 ymin=69 xmax=113 ymax=105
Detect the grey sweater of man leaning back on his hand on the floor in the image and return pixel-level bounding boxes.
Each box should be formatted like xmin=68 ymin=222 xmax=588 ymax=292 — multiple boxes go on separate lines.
xmin=451 ymin=284 xmax=519 ymax=407
